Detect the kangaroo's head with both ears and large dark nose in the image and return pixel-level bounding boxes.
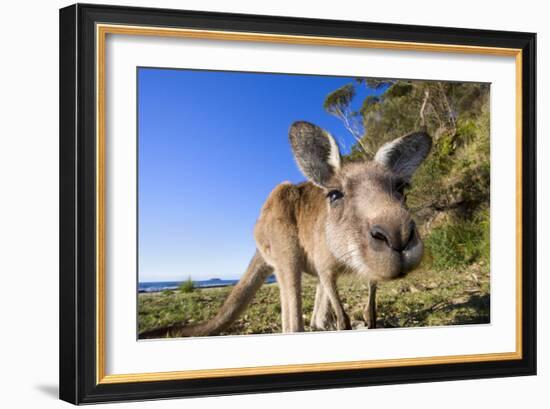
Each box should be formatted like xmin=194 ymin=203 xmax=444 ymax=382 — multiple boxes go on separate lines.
xmin=290 ymin=122 xmax=432 ymax=280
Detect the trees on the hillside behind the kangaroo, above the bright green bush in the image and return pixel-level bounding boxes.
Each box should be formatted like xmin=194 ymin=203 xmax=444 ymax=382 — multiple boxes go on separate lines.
xmin=324 ymin=78 xmax=490 ymax=226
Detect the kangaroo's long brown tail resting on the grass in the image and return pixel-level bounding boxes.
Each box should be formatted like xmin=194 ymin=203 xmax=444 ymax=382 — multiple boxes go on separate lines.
xmin=139 ymin=251 xmax=273 ymax=339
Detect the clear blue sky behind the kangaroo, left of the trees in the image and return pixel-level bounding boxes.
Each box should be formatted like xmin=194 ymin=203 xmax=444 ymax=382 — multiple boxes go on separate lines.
xmin=138 ymin=68 xmax=382 ymax=282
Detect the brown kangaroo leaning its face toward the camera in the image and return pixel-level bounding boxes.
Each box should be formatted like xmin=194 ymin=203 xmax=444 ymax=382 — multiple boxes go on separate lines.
xmin=140 ymin=121 xmax=432 ymax=338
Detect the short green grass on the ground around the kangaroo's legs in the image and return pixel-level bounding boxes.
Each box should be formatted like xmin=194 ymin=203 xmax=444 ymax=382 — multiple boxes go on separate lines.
xmin=138 ymin=261 xmax=490 ymax=335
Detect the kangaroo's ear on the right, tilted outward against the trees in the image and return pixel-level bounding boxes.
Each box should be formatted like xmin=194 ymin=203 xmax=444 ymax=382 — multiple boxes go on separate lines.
xmin=374 ymin=132 xmax=432 ymax=180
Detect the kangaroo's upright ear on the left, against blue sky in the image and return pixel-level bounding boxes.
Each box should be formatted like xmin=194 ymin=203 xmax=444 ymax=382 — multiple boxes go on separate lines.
xmin=289 ymin=121 xmax=342 ymax=187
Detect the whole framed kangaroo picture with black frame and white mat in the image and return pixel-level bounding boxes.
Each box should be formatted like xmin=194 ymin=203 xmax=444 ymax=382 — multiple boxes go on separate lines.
xmin=60 ymin=5 xmax=536 ymax=404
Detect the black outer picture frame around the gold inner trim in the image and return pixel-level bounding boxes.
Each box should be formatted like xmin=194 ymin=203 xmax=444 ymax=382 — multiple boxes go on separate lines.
xmin=59 ymin=4 xmax=537 ymax=404
